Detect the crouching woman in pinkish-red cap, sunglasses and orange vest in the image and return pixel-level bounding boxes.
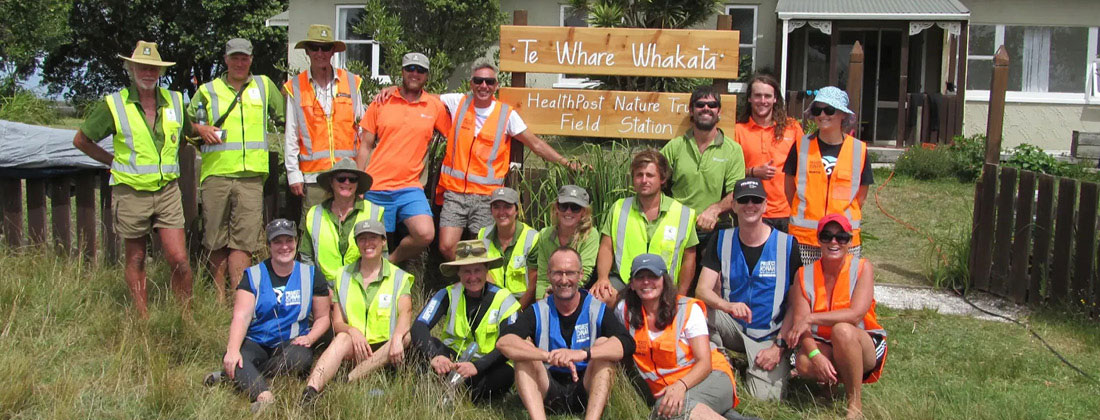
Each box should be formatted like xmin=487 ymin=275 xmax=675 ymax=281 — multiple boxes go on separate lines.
xmin=784 ymin=213 xmax=887 ymax=419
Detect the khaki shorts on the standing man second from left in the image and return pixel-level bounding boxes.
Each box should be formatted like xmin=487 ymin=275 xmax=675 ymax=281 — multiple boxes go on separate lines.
xmin=199 ymin=176 xmax=264 ymax=252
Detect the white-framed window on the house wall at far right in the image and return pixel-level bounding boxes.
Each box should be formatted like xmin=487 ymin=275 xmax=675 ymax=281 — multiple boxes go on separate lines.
xmin=967 ymin=25 xmax=1096 ymax=103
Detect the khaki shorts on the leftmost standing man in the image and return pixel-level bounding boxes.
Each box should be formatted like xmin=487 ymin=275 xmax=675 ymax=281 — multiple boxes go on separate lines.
xmin=111 ymin=181 xmax=184 ymax=240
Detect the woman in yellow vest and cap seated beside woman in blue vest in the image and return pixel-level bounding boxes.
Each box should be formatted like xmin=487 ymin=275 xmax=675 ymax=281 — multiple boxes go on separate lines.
xmin=301 ymin=219 xmax=413 ymax=402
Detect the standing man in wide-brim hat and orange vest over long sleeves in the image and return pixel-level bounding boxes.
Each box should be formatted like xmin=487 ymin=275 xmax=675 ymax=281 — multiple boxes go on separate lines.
xmin=284 ymin=25 xmax=365 ymax=213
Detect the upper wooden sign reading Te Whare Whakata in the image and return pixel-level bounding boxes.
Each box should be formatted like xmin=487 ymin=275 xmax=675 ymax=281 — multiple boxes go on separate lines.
xmin=501 ymin=25 xmax=740 ymax=79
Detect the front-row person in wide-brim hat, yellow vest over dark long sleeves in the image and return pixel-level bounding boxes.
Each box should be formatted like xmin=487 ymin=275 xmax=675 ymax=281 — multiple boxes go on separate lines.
xmin=411 ymin=240 xmax=519 ymax=401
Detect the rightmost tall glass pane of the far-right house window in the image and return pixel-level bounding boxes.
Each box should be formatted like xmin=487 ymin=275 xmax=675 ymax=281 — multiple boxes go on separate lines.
xmin=1048 ymin=27 xmax=1089 ymax=93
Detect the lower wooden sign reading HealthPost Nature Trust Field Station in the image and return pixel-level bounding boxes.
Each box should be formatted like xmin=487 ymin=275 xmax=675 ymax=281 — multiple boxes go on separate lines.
xmin=501 ymin=88 xmax=737 ymax=140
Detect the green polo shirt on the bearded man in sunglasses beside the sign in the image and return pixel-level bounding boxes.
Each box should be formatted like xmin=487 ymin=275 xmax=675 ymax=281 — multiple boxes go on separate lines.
xmin=661 ymin=129 xmax=745 ymax=214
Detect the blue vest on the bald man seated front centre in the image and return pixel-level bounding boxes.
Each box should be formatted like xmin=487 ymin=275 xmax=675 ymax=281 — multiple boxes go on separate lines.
xmin=535 ymin=290 xmax=606 ymax=374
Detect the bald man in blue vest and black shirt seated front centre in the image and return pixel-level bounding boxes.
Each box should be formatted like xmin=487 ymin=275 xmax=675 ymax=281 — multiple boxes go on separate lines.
xmin=497 ymin=246 xmax=634 ymax=420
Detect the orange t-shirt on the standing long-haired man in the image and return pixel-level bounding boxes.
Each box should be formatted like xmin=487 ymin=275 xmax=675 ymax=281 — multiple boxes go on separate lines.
xmin=734 ymin=118 xmax=803 ymax=219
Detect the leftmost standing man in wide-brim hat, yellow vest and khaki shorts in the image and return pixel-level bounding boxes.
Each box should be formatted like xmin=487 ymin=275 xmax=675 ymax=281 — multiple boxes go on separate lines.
xmin=73 ymin=41 xmax=191 ymax=317
